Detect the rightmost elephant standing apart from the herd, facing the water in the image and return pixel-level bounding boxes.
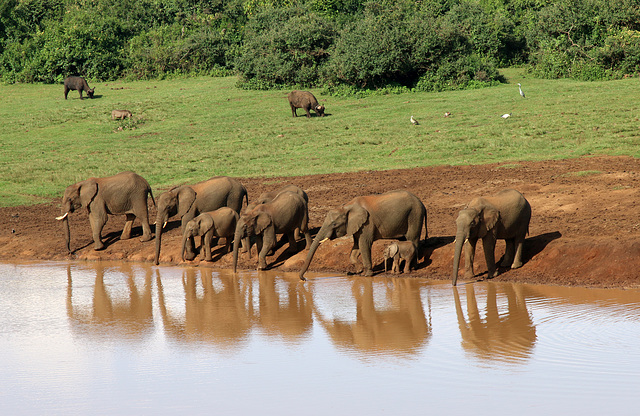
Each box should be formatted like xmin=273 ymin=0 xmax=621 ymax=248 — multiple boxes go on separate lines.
xmin=451 ymin=189 xmax=531 ymax=286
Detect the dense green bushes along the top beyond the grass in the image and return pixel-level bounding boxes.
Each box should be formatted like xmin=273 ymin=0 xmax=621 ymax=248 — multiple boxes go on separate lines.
xmin=0 ymin=0 xmax=640 ymax=91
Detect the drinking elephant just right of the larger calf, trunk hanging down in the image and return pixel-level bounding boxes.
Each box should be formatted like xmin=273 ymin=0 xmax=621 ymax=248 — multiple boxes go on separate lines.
xmin=233 ymin=192 xmax=311 ymax=273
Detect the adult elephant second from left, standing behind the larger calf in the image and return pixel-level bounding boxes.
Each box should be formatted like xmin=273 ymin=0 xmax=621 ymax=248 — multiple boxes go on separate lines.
xmin=155 ymin=176 xmax=249 ymax=264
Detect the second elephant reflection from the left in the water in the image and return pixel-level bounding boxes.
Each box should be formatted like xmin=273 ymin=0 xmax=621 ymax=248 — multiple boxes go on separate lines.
xmin=156 ymin=267 xmax=255 ymax=347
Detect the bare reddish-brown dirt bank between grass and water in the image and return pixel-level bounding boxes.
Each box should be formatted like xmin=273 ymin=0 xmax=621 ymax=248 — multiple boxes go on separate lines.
xmin=0 ymin=156 xmax=640 ymax=288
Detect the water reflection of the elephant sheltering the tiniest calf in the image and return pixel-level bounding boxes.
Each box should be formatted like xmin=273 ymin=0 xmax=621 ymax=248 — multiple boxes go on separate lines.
xmin=314 ymin=278 xmax=431 ymax=356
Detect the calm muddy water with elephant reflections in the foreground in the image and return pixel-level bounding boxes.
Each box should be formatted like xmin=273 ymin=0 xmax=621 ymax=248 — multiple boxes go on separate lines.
xmin=0 ymin=263 xmax=640 ymax=415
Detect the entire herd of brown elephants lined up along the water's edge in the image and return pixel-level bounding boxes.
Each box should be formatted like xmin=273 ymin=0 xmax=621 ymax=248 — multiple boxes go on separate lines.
xmin=56 ymin=172 xmax=531 ymax=286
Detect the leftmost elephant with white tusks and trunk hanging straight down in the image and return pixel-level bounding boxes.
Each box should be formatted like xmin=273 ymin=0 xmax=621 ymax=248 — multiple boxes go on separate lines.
xmin=56 ymin=172 xmax=155 ymax=253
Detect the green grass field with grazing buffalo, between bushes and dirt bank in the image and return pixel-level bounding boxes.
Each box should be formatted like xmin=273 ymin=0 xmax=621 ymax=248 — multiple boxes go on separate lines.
xmin=0 ymin=69 xmax=640 ymax=206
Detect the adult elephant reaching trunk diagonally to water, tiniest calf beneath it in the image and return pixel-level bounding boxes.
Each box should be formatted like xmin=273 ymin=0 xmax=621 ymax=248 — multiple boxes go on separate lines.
xmin=300 ymin=190 xmax=428 ymax=280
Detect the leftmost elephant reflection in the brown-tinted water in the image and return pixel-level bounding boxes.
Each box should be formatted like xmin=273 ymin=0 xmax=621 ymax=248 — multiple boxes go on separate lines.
xmin=67 ymin=263 xmax=153 ymax=338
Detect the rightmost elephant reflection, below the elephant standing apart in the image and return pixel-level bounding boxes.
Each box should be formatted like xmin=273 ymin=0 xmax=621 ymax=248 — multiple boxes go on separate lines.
xmin=453 ymin=282 xmax=536 ymax=361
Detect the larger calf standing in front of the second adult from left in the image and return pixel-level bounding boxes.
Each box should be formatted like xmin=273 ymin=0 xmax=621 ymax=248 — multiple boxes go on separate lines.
xmin=181 ymin=207 xmax=238 ymax=261
